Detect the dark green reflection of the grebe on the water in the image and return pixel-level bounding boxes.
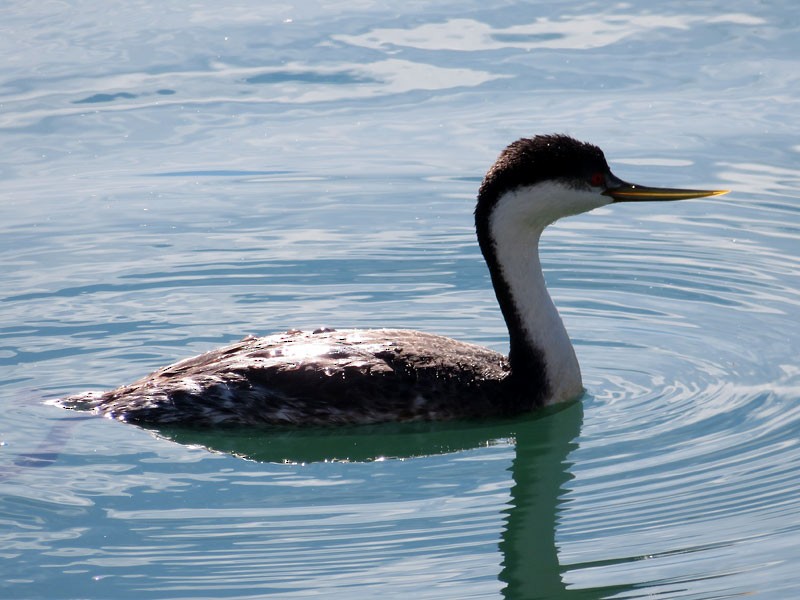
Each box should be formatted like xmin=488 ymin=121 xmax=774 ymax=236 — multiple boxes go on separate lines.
xmin=155 ymin=402 xmax=629 ymax=600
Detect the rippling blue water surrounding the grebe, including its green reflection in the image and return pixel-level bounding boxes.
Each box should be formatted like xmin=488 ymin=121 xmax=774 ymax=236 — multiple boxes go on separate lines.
xmin=0 ymin=1 xmax=800 ymax=600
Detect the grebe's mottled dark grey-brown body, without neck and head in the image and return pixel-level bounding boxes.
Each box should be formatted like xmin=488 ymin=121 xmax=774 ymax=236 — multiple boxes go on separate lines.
xmin=60 ymin=329 xmax=517 ymax=426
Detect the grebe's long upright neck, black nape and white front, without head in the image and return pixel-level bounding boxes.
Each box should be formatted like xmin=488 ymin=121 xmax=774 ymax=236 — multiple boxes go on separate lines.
xmin=476 ymin=188 xmax=583 ymax=405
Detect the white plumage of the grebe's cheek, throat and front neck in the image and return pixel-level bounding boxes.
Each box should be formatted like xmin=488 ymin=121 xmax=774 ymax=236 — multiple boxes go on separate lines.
xmin=489 ymin=180 xmax=611 ymax=404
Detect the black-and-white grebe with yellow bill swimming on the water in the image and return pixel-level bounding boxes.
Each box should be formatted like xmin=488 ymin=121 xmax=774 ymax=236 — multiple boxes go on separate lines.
xmin=57 ymin=135 xmax=727 ymax=426
